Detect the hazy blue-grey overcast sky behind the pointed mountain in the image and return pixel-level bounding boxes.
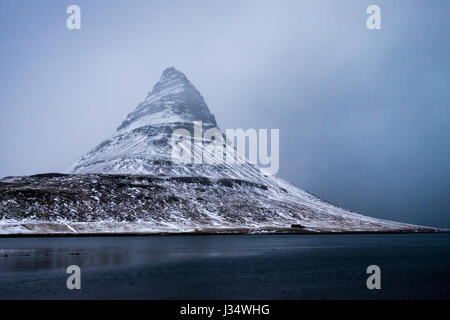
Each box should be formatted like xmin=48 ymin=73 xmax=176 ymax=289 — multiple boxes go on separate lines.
xmin=0 ymin=0 xmax=450 ymax=227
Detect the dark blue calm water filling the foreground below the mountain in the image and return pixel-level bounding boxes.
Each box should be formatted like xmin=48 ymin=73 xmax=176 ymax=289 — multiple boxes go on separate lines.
xmin=0 ymin=234 xmax=450 ymax=300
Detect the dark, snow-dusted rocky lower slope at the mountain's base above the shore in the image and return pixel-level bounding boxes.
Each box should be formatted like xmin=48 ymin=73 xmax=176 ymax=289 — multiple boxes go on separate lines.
xmin=0 ymin=174 xmax=433 ymax=234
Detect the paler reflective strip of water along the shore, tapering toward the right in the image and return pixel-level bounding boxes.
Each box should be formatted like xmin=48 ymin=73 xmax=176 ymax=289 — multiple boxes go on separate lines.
xmin=0 ymin=235 xmax=449 ymax=272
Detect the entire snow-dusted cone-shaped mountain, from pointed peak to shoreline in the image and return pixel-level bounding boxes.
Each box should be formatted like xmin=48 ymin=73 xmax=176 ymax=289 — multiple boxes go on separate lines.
xmin=0 ymin=68 xmax=436 ymax=234
